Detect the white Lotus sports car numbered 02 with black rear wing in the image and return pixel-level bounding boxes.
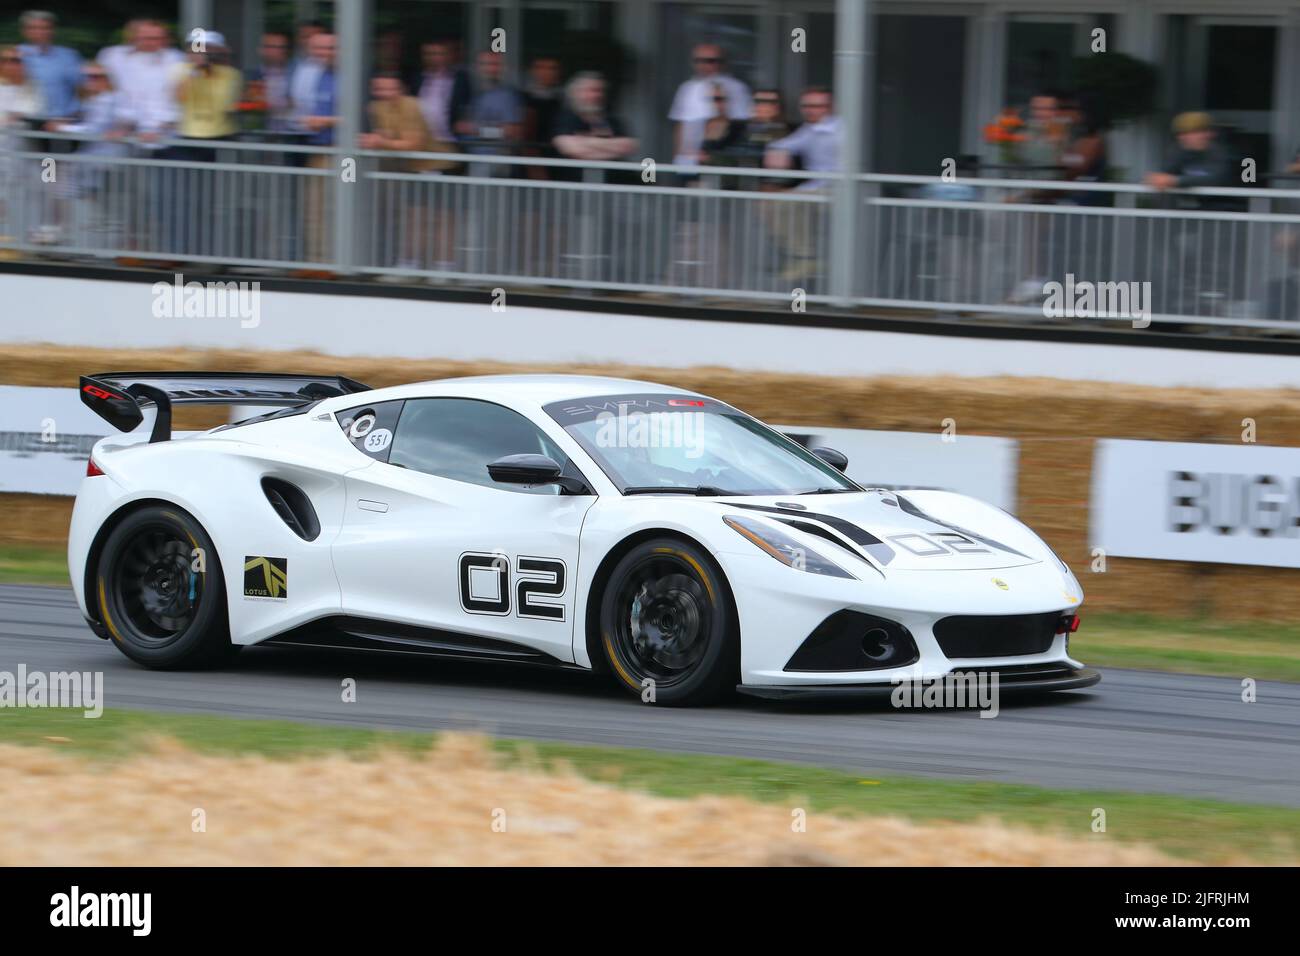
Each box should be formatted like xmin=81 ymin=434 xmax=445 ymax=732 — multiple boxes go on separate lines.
xmin=69 ymin=372 xmax=1100 ymax=705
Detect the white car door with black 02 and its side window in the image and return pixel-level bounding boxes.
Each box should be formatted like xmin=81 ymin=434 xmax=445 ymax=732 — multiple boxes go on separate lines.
xmin=334 ymin=398 xmax=595 ymax=661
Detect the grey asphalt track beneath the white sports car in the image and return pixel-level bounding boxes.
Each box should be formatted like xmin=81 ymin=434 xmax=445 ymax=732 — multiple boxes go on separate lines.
xmin=0 ymin=585 xmax=1300 ymax=806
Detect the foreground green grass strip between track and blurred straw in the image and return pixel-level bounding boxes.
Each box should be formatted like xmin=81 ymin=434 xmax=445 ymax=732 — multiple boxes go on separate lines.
xmin=0 ymin=709 xmax=1300 ymax=864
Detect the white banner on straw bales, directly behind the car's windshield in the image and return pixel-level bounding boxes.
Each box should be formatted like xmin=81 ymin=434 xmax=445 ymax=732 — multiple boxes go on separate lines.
xmin=774 ymin=425 xmax=1019 ymax=512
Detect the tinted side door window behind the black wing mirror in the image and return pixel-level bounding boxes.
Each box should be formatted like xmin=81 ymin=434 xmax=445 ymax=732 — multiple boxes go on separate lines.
xmin=389 ymin=398 xmax=576 ymax=494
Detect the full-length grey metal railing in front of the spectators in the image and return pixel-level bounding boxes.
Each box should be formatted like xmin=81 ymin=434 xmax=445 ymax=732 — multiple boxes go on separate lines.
xmin=0 ymin=131 xmax=1300 ymax=330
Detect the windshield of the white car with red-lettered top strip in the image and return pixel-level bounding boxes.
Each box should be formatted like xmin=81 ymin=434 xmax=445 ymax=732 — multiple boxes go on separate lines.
xmin=546 ymin=394 xmax=861 ymax=494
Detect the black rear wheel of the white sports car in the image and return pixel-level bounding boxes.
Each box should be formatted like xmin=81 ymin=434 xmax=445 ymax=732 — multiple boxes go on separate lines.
xmin=95 ymin=506 xmax=241 ymax=670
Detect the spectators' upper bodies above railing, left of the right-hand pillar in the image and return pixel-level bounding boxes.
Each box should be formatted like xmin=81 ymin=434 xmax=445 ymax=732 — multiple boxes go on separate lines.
xmin=0 ymin=10 xmax=839 ymax=182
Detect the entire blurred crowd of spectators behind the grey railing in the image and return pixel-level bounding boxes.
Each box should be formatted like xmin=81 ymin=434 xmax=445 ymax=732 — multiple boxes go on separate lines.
xmin=0 ymin=10 xmax=1279 ymax=306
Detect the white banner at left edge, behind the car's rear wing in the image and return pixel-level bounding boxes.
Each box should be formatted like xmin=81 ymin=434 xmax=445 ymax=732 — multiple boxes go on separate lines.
xmin=0 ymin=385 xmax=113 ymax=494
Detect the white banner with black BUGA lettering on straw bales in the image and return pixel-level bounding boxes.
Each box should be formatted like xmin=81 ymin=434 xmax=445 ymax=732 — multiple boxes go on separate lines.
xmin=1092 ymin=440 xmax=1300 ymax=567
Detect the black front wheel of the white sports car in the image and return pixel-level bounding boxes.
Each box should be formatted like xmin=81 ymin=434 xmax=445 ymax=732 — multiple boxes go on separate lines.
xmin=601 ymin=537 xmax=740 ymax=706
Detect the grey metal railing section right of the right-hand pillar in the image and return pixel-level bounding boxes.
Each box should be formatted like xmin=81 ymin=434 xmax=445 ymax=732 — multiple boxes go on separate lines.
xmin=854 ymin=176 xmax=1300 ymax=329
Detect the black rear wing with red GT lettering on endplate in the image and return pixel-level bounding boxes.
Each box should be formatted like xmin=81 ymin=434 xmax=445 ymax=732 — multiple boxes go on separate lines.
xmin=81 ymin=372 xmax=369 ymax=442
